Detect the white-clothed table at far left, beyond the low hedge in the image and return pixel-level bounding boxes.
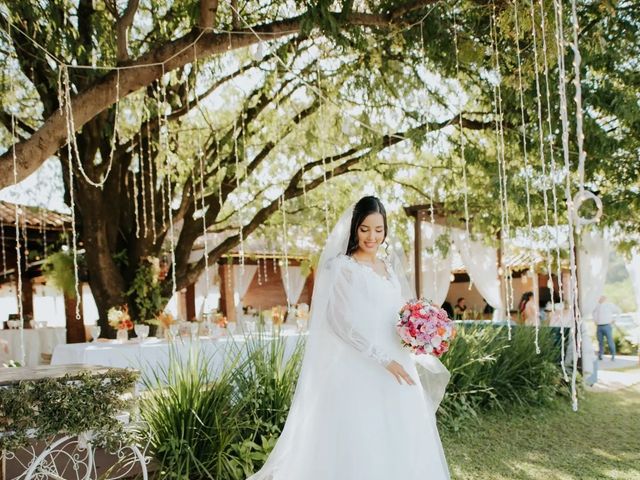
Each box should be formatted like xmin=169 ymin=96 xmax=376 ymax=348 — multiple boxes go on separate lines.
xmin=0 ymin=327 xmax=67 ymax=367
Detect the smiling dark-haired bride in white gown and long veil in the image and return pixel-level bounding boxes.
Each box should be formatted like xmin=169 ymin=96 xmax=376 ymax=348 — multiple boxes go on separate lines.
xmin=249 ymin=197 xmax=449 ymax=480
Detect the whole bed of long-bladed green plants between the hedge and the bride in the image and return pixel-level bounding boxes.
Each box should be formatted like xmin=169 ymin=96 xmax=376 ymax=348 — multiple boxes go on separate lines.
xmin=140 ymin=337 xmax=302 ymax=480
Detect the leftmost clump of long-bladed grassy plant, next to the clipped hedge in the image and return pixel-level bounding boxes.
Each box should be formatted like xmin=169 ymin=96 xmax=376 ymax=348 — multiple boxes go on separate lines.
xmin=140 ymin=347 xmax=242 ymax=479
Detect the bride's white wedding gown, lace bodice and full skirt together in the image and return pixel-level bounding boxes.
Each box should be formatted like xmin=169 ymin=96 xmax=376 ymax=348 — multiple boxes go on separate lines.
xmin=250 ymin=260 xmax=449 ymax=480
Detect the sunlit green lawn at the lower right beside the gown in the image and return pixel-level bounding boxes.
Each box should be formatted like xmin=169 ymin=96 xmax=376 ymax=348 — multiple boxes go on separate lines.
xmin=441 ymin=385 xmax=640 ymax=480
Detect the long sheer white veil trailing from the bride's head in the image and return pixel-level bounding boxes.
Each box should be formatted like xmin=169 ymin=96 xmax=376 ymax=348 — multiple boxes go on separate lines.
xmin=247 ymin=204 xmax=450 ymax=480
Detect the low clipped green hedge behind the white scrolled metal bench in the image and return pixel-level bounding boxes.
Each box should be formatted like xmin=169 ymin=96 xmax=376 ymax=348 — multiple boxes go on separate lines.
xmin=0 ymin=370 xmax=138 ymax=450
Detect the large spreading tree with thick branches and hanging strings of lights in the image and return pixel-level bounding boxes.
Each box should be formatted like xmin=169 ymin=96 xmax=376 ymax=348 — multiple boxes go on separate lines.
xmin=0 ymin=0 xmax=638 ymax=330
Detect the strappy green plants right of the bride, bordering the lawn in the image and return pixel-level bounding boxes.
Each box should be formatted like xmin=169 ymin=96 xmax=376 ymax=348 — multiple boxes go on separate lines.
xmin=438 ymin=326 xmax=564 ymax=430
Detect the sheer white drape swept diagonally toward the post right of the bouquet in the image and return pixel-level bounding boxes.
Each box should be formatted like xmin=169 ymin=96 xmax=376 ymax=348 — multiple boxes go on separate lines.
xmin=451 ymin=229 xmax=505 ymax=320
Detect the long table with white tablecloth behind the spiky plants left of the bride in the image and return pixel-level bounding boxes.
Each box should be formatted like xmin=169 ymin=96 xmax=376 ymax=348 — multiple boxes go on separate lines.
xmin=51 ymin=330 xmax=303 ymax=378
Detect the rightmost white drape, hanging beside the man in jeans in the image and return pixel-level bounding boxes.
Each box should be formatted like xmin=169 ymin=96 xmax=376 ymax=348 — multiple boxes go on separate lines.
xmin=578 ymin=231 xmax=610 ymax=318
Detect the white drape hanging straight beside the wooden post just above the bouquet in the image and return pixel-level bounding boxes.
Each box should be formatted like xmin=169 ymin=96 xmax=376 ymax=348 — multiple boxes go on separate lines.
xmin=420 ymin=222 xmax=452 ymax=305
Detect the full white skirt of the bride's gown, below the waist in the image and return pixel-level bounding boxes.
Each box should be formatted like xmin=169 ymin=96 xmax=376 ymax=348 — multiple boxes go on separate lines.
xmin=250 ymin=336 xmax=449 ymax=480
